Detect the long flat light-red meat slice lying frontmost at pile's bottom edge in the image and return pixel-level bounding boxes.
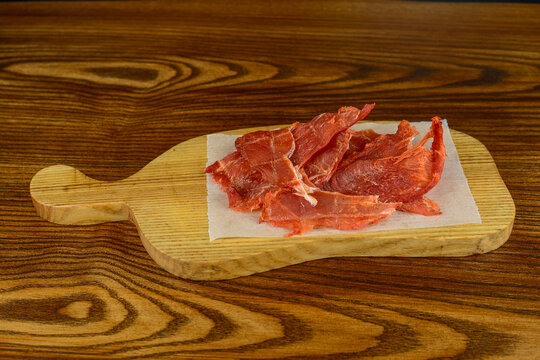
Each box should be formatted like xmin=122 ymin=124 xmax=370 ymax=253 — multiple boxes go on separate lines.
xmin=260 ymin=190 xmax=399 ymax=237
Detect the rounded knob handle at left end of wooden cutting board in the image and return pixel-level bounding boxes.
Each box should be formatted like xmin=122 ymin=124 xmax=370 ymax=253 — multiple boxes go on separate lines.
xmin=30 ymin=165 xmax=129 ymax=225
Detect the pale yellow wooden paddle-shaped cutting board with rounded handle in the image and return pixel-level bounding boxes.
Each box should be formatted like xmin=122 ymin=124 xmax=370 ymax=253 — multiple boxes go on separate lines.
xmin=30 ymin=126 xmax=515 ymax=280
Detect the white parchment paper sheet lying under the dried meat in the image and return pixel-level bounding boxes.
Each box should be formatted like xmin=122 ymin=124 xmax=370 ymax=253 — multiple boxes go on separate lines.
xmin=206 ymin=120 xmax=482 ymax=241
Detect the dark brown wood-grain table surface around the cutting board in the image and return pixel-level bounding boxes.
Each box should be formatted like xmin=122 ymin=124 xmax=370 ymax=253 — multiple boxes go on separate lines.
xmin=0 ymin=1 xmax=540 ymax=359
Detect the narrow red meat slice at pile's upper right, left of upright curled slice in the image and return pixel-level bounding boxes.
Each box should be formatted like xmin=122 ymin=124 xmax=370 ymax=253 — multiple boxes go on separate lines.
xmin=339 ymin=120 xmax=418 ymax=167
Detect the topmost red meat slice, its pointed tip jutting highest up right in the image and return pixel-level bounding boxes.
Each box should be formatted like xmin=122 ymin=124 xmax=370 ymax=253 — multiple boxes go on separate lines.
xmin=290 ymin=104 xmax=375 ymax=168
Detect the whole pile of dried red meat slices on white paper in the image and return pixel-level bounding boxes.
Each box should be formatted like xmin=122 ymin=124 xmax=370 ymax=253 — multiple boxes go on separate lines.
xmin=205 ymin=104 xmax=446 ymax=236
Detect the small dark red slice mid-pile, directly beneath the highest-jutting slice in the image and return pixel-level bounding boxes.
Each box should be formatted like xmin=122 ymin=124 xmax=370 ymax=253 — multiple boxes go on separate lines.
xmin=303 ymin=129 xmax=353 ymax=187
